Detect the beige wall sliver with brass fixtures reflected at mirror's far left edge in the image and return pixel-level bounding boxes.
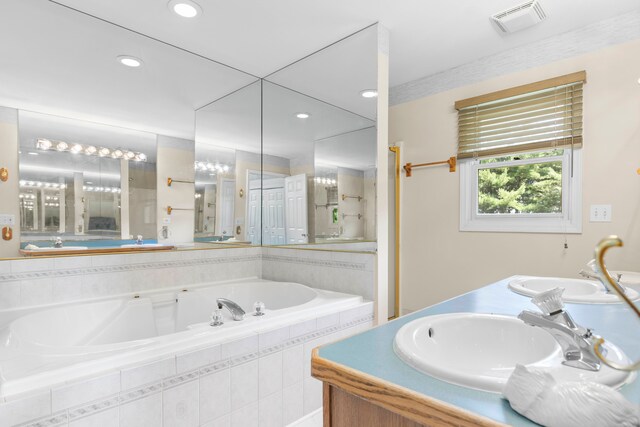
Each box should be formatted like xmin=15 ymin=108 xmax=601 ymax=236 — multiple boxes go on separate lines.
xmin=0 ymin=107 xmax=20 ymax=258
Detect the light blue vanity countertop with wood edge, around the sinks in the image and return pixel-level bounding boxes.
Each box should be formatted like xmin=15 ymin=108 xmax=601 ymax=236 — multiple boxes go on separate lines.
xmin=319 ymin=278 xmax=640 ymax=426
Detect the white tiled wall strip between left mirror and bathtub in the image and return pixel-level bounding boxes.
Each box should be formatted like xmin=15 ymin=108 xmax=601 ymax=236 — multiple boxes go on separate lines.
xmin=0 ymin=247 xmax=262 ymax=310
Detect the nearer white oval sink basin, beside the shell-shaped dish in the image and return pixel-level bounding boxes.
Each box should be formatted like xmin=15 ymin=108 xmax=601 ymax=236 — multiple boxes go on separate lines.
xmin=393 ymin=313 xmax=630 ymax=393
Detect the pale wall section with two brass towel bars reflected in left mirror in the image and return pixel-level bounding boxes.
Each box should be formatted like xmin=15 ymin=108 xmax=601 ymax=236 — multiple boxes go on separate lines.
xmin=156 ymin=135 xmax=195 ymax=243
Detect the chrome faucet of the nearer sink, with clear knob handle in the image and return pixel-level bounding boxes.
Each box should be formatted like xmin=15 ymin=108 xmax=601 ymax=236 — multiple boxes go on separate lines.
xmin=518 ymin=288 xmax=605 ymax=371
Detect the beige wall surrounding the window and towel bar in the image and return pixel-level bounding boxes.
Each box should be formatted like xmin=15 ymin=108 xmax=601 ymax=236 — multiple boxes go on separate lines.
xmin=389 ymin=40 xmax=640 ymax=312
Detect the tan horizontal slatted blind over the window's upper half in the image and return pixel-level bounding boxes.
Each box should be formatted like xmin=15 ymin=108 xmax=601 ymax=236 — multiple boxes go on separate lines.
xmin=456 ymin=72 xmax=586 ymax=159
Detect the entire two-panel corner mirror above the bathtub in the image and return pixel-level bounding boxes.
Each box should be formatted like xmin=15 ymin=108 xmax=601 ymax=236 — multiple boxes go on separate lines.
xmin=0 ymin=0 xmax=377 ymax=256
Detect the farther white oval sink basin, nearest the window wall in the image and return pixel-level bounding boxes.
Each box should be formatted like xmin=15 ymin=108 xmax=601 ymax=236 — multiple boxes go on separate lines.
xmin=509 ymin=277 xmax=639 ymax=304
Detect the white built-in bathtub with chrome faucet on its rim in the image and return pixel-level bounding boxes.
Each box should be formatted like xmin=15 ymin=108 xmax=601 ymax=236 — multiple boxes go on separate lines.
xmin=0 ymin=279 xmax=363 ymax=398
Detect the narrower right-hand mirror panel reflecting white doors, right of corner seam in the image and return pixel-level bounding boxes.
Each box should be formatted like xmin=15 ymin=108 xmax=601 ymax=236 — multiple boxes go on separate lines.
xmin=262 ymin=26 xmax=378 ymax=245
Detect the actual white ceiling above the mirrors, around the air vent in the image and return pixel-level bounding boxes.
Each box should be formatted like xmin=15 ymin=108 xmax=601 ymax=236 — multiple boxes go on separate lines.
xmin=50 ymin=0 xmax=640 ymax=86
